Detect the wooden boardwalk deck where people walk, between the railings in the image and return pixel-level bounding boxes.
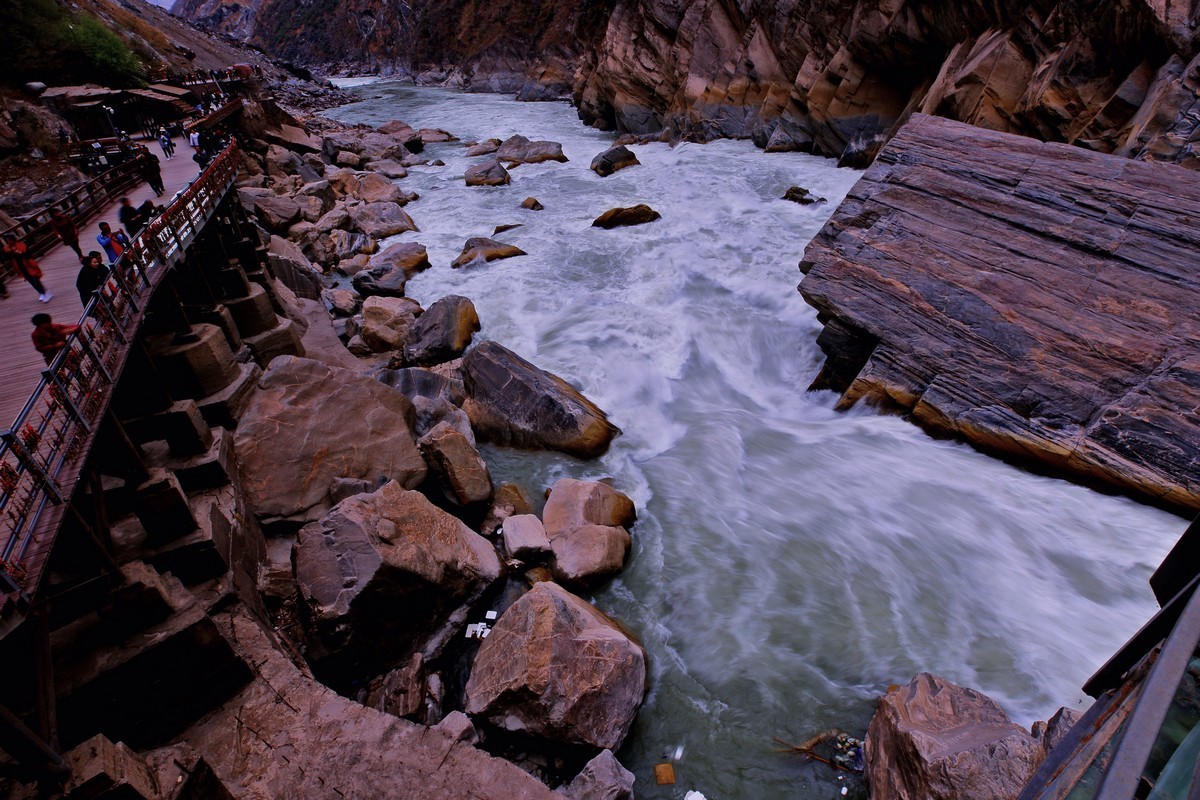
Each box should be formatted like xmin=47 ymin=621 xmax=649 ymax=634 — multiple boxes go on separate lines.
xmin=0 ymin=138 xmax=199 ymax=431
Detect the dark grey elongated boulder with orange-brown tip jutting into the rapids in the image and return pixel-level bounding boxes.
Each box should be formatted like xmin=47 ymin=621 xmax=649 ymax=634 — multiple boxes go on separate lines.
xmin=462 ymin=342 xmax=620 ymax=458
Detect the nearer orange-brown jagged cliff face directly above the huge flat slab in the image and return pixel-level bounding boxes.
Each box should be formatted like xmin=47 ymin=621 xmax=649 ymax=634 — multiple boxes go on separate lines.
xmin=575 ymin=0 xmax=1195 ymax=163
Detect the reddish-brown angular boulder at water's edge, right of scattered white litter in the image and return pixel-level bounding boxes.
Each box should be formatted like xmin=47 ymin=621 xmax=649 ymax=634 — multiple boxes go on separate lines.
xmin=466 ymin=583 xmax=646 ymax=750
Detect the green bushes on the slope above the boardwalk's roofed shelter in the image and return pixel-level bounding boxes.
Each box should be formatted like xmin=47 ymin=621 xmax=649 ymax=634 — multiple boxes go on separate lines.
xmin=0 ymin=0 xmax=143 ymax=86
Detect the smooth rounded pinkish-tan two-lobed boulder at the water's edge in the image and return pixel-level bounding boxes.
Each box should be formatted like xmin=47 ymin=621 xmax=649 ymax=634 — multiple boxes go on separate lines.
xmin=542 ymin=477 xmax=635 ymax=585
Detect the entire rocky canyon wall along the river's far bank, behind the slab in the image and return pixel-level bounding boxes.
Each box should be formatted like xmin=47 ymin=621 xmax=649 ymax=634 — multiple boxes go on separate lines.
xmin=175 ymin=0 xmax=1200 ymax=166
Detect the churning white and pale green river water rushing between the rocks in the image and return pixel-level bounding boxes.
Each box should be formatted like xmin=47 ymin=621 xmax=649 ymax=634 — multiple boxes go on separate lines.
xmin=330 ymin=83 xmax=1184 ymax=800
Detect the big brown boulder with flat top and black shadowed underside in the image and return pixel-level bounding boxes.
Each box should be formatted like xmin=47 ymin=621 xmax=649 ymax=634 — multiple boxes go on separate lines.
xmin=292 ymin=484 xmax=500 ymax=662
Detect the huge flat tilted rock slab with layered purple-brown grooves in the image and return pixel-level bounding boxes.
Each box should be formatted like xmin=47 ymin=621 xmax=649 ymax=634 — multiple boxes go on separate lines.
xmin=800 ymin=114 xmax=1200 ymax=511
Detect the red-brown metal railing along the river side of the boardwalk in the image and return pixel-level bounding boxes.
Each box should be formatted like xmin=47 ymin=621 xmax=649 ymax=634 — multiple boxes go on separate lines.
xmin=0 ymin=142 xmax=240 ymax=602
